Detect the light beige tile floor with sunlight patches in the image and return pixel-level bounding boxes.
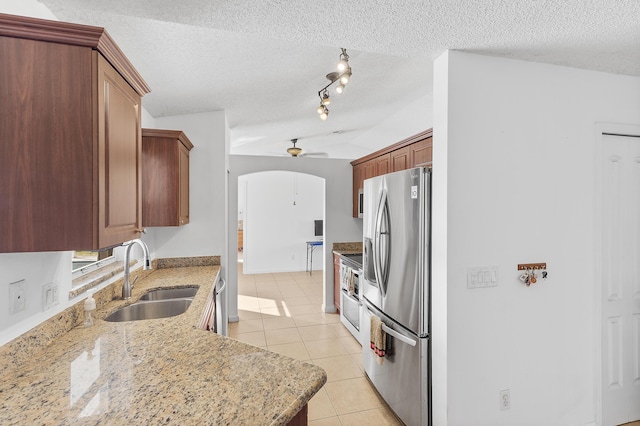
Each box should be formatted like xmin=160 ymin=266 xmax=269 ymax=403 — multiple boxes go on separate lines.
xmin=229 ymin=263 xmax=402 ymax=426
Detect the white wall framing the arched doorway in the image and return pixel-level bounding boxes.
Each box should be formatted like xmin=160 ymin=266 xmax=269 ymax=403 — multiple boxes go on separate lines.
xmin=227 ymin=155 xmax=362 ymax=321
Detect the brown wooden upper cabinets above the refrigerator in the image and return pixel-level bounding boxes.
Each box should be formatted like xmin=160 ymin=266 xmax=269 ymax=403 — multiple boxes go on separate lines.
xmin=351 ymin=129 xmax=433 ymax=218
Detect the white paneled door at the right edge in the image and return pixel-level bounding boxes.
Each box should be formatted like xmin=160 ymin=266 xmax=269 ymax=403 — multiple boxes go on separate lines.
xmin=601 ymin=135 xmax=640 ymax=426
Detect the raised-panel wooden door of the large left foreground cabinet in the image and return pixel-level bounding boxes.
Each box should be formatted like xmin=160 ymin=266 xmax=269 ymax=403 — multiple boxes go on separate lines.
xmin=95 ymin=51 xmax=142 ymax=248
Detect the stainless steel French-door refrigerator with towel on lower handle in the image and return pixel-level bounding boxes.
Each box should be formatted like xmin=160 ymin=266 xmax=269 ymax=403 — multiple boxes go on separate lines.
xmin=361 ymin=168 xmax=431 ymax=425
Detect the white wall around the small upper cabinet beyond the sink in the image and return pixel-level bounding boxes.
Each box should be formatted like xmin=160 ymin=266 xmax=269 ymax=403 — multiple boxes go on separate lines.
xmin=144 ymin=111 xmax=229 ymax=258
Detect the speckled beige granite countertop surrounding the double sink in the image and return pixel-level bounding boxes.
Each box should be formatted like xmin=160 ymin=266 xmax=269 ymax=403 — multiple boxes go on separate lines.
xmin=0 ymin=266 xmax=326 ymax=425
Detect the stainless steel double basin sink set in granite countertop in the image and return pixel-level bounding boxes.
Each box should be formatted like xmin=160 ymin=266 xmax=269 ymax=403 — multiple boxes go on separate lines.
xmin=105 ymin=287 xmax=198 ymax=322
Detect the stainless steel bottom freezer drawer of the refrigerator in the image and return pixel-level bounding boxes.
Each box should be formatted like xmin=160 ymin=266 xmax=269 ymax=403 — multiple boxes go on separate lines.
xmin=361 ymin=303 xmax=430 ymax=426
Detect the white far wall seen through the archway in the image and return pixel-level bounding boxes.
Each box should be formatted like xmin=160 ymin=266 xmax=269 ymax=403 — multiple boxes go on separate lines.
xmin=239 ymin=171 xmax=325 ymax=274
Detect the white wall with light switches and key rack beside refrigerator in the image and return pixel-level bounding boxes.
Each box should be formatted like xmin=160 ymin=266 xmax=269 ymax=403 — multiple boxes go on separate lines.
xmin=432 ymin=51 xmax=640 ymax=425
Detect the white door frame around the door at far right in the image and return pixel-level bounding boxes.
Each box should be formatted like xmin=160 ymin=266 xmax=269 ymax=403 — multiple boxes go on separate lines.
xmin=594 ymin=123 xmax=640 ymax=425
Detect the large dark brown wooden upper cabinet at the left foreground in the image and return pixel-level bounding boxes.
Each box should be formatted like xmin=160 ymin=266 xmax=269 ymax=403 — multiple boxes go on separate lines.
xmin=0 ymin=14 xmax=149 ymax=253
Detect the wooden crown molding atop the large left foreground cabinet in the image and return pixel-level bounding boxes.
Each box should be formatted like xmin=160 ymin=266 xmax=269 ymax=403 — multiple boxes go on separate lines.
xmin=0 ymin=13 xmax=151 ymax=96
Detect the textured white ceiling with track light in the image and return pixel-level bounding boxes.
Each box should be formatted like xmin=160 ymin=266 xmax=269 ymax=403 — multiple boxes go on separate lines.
xmin=40 ymin=0 xmax=640 ymax=157
